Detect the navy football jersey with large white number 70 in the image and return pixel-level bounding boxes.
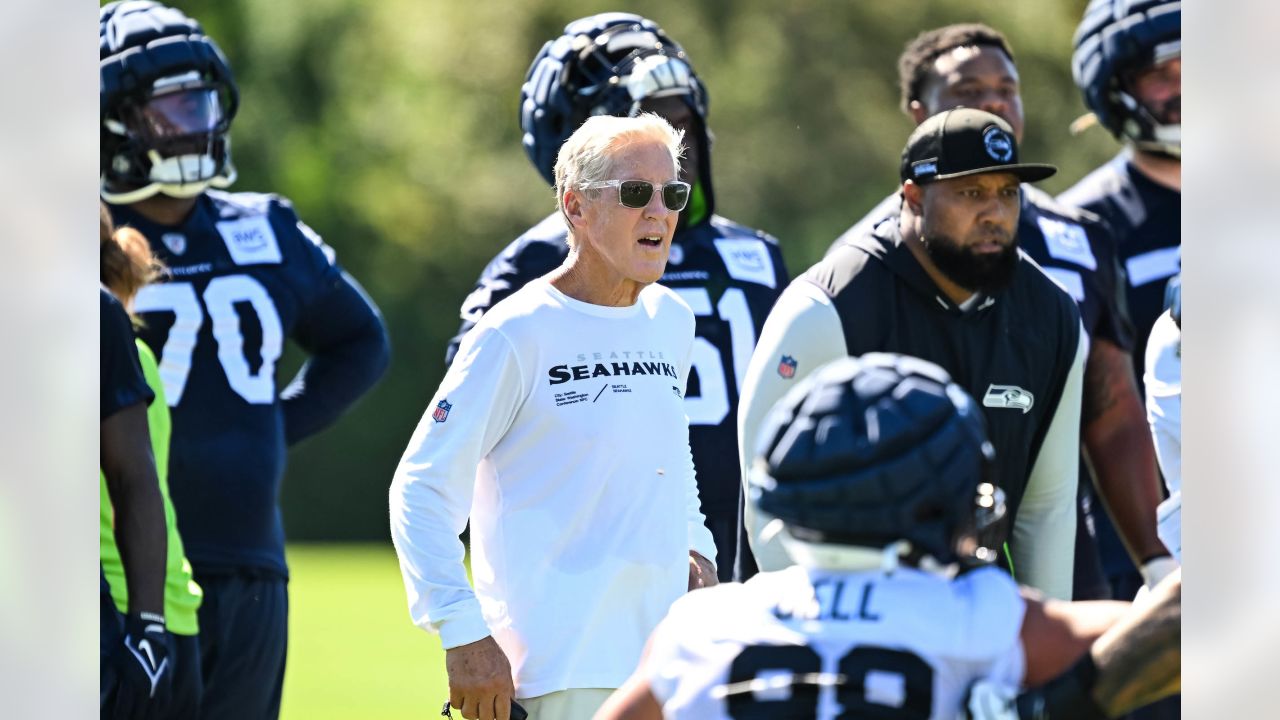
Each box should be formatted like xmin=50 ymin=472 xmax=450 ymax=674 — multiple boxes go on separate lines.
xmin=111 ymin=191 xmax=389 ymax=577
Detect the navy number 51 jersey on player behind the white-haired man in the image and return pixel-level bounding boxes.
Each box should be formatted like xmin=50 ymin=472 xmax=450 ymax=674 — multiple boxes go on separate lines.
xmin=445 ymin=213 xmax=787 ymax=580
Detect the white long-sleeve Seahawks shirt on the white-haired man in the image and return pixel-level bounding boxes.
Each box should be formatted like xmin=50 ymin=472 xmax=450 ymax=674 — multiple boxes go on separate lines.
xmin=390 ymin=275 xmax=716 ymax=697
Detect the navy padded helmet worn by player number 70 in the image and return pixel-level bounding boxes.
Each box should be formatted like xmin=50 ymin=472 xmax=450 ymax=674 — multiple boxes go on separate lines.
xmin=99 ymin=0 xmax=239 ymax=204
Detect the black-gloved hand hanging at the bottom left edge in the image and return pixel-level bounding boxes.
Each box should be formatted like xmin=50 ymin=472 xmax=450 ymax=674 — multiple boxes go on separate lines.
xmin=109 ymin=612 xmax=173 ymax=719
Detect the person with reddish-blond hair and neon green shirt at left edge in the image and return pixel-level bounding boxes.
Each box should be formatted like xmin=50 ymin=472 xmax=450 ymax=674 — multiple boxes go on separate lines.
xmin=99 ymin=205 xmax=204 ymax=719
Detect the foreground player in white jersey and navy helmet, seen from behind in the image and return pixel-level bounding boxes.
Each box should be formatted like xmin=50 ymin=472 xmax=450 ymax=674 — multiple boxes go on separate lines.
xmin=596 ymin=352 xmax=1128 ymax=720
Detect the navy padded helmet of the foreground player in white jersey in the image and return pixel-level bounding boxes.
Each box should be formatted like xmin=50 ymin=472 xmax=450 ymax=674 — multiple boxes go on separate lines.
xmin=749 ymin=352 xmax=1005 ymax=569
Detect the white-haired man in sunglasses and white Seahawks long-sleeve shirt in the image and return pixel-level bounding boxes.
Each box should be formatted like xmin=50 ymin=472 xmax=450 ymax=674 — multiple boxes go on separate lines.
xmin=390 ymin=114 xmax=728 ymax=720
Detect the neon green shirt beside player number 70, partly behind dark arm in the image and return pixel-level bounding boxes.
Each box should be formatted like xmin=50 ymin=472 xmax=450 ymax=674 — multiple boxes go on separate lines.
xmin=97 ymin=340 xmax=205 ymax=635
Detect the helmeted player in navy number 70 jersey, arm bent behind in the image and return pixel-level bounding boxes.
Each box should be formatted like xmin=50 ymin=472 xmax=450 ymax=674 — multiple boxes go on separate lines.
xmin=99 ymin=1 xmax=389 ymax=720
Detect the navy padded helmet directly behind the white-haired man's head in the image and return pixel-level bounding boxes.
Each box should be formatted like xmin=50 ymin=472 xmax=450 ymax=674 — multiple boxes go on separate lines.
xmin=520 ymin=13 xmax=710 ymax=190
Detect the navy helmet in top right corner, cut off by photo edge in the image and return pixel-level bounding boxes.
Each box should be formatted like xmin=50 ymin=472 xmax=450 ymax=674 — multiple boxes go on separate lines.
xmin=1071 ymin=0 xmax=1183 ymax=158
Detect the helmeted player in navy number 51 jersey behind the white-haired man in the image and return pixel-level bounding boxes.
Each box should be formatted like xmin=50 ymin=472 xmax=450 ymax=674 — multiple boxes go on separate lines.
xmin=445 ymin=13 xmax=787 ymax=580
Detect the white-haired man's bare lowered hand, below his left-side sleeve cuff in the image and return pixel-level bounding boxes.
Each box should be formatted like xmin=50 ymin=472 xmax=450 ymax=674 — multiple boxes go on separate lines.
xmin=444 ymin=635 xmax=516 ymax=720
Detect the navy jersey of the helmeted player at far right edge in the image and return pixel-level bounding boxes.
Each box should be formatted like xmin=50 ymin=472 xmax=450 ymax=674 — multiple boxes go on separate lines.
xmin=1059 ymin=152 xmax=1183 ymax=391
